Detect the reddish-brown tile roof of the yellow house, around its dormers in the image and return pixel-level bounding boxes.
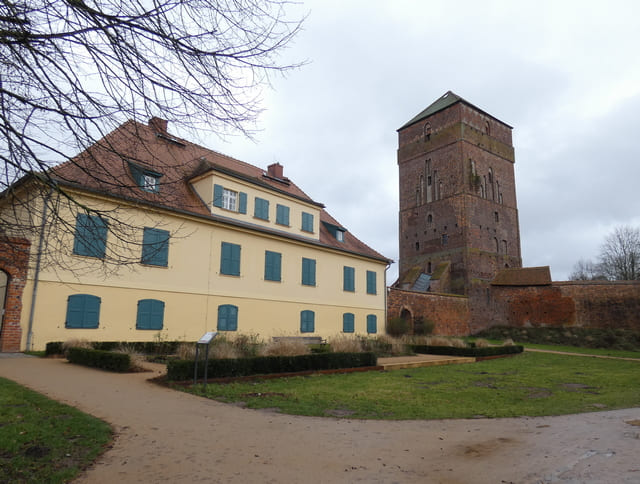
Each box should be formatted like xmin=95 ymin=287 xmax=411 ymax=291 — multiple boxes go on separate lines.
xmin=50 ymin=118 xmax=391 ymax=262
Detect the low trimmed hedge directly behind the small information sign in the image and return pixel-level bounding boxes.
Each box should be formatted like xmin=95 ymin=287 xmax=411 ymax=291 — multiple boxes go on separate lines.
xmin=167 ymin=353 xmax=378 ymax=380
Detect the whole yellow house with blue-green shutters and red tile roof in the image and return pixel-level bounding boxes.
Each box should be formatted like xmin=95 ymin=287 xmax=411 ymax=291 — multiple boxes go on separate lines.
xmin=0 ymin=118 xmax=391 ymax=351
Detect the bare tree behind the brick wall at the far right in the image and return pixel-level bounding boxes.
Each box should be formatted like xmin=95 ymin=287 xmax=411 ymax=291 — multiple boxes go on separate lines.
xmin=569 ymin=226 xmax=640 ymax=281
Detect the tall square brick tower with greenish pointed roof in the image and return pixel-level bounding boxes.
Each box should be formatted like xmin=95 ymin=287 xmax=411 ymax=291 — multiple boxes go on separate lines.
xmin=398 ymin=91 xmax=522 ymax=294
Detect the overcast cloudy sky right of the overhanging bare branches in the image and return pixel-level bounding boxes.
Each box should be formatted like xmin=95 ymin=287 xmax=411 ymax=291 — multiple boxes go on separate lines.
xmin=207 ymin=0 xmax=640 ymax=284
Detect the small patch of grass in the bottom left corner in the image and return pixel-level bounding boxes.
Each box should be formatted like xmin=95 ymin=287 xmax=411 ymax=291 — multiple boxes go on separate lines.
xmin=0 ymin=378 xmax=112 ymax=483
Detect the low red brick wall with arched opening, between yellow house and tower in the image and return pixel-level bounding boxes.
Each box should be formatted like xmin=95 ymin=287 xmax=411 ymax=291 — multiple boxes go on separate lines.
xmin=387 ymin=288 xmax=469 ymax=336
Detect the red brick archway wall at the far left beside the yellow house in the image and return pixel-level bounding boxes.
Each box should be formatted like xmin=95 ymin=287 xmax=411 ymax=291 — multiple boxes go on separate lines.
xmin=0 ymin=237 xmax=30 ymax=352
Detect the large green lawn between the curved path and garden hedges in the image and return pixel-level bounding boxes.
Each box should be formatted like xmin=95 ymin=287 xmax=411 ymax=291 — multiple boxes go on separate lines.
xmin=180 ymin=353 xmax=640 ymax=420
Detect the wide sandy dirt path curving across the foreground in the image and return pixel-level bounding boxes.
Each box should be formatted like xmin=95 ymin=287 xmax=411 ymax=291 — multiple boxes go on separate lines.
xmin=0 ymin=358 xmax=640 ymax=484
